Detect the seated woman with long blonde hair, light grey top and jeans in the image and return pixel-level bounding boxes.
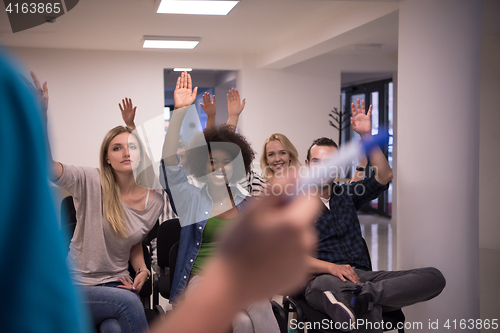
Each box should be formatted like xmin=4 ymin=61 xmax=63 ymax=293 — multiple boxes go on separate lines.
xmin=36 ymin=72 xmax=163 ymax=333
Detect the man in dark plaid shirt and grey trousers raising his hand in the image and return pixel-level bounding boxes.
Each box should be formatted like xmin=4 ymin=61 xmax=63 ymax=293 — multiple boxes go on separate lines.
xmin=305 ymin=99 xmax=446 ymax=332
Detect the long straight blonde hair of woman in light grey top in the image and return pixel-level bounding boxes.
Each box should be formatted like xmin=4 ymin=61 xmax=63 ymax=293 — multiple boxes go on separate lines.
xmin=99 ymin=126 xmax=149 ymax=238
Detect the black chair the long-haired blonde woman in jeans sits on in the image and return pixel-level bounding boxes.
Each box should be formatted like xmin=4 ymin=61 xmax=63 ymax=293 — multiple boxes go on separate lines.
xmin=61 ymin=196 xmax=164 ymax=323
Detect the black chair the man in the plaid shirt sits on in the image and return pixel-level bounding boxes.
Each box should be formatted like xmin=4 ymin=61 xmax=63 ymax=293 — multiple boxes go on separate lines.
xmin=283 ymin=239 xmax=405 ymax=333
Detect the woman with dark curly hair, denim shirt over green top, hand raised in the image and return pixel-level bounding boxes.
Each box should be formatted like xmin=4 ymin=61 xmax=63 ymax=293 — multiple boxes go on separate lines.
xmin=162 ymin=72 xmax=279 ymax=333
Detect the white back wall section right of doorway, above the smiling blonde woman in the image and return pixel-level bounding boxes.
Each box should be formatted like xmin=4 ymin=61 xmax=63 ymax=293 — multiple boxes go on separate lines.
xmin=238 ymin=56 xmax=340 ymax=170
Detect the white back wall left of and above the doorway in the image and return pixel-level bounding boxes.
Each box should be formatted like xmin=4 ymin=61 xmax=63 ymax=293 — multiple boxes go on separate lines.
xmin=13 ymin=49 xmax=241 ymax=166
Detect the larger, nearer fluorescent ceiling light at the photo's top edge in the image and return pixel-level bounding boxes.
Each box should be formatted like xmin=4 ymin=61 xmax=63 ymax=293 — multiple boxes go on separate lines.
xmin=157 ymin=0 xmax=239 ymax=15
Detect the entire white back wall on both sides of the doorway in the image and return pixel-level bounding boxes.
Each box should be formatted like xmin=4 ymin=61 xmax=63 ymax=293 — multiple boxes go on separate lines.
xmin=14 ymin=48 xmax=340 ymax=174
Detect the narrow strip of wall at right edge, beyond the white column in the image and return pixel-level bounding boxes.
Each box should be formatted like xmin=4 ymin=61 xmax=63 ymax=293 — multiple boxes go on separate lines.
xmin=479 ymin=0 xmax=500 ymax=324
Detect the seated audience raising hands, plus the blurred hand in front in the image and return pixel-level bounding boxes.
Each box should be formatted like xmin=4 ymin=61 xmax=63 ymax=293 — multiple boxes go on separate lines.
xmin=0 ymin=45 xmax=445 ymax=333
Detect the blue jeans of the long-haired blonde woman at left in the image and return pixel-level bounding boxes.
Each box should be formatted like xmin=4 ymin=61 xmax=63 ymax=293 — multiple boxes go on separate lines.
xmin=82 ymin=282 xmax=148 ymax=333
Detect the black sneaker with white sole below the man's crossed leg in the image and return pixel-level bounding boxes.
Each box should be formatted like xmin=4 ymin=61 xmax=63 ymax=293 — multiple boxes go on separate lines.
xmin=323 ymin=287 xmax=373 ymax=332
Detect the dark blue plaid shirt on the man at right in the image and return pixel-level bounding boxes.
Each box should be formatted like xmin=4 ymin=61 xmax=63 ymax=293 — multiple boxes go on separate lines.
xmin=316 ymin=176 xmax=389 ymax=270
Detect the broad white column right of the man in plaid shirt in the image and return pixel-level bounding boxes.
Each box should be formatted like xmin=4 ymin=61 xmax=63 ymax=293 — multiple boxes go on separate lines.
xmin=396 ymin=0 xmax=482 ymax=332
